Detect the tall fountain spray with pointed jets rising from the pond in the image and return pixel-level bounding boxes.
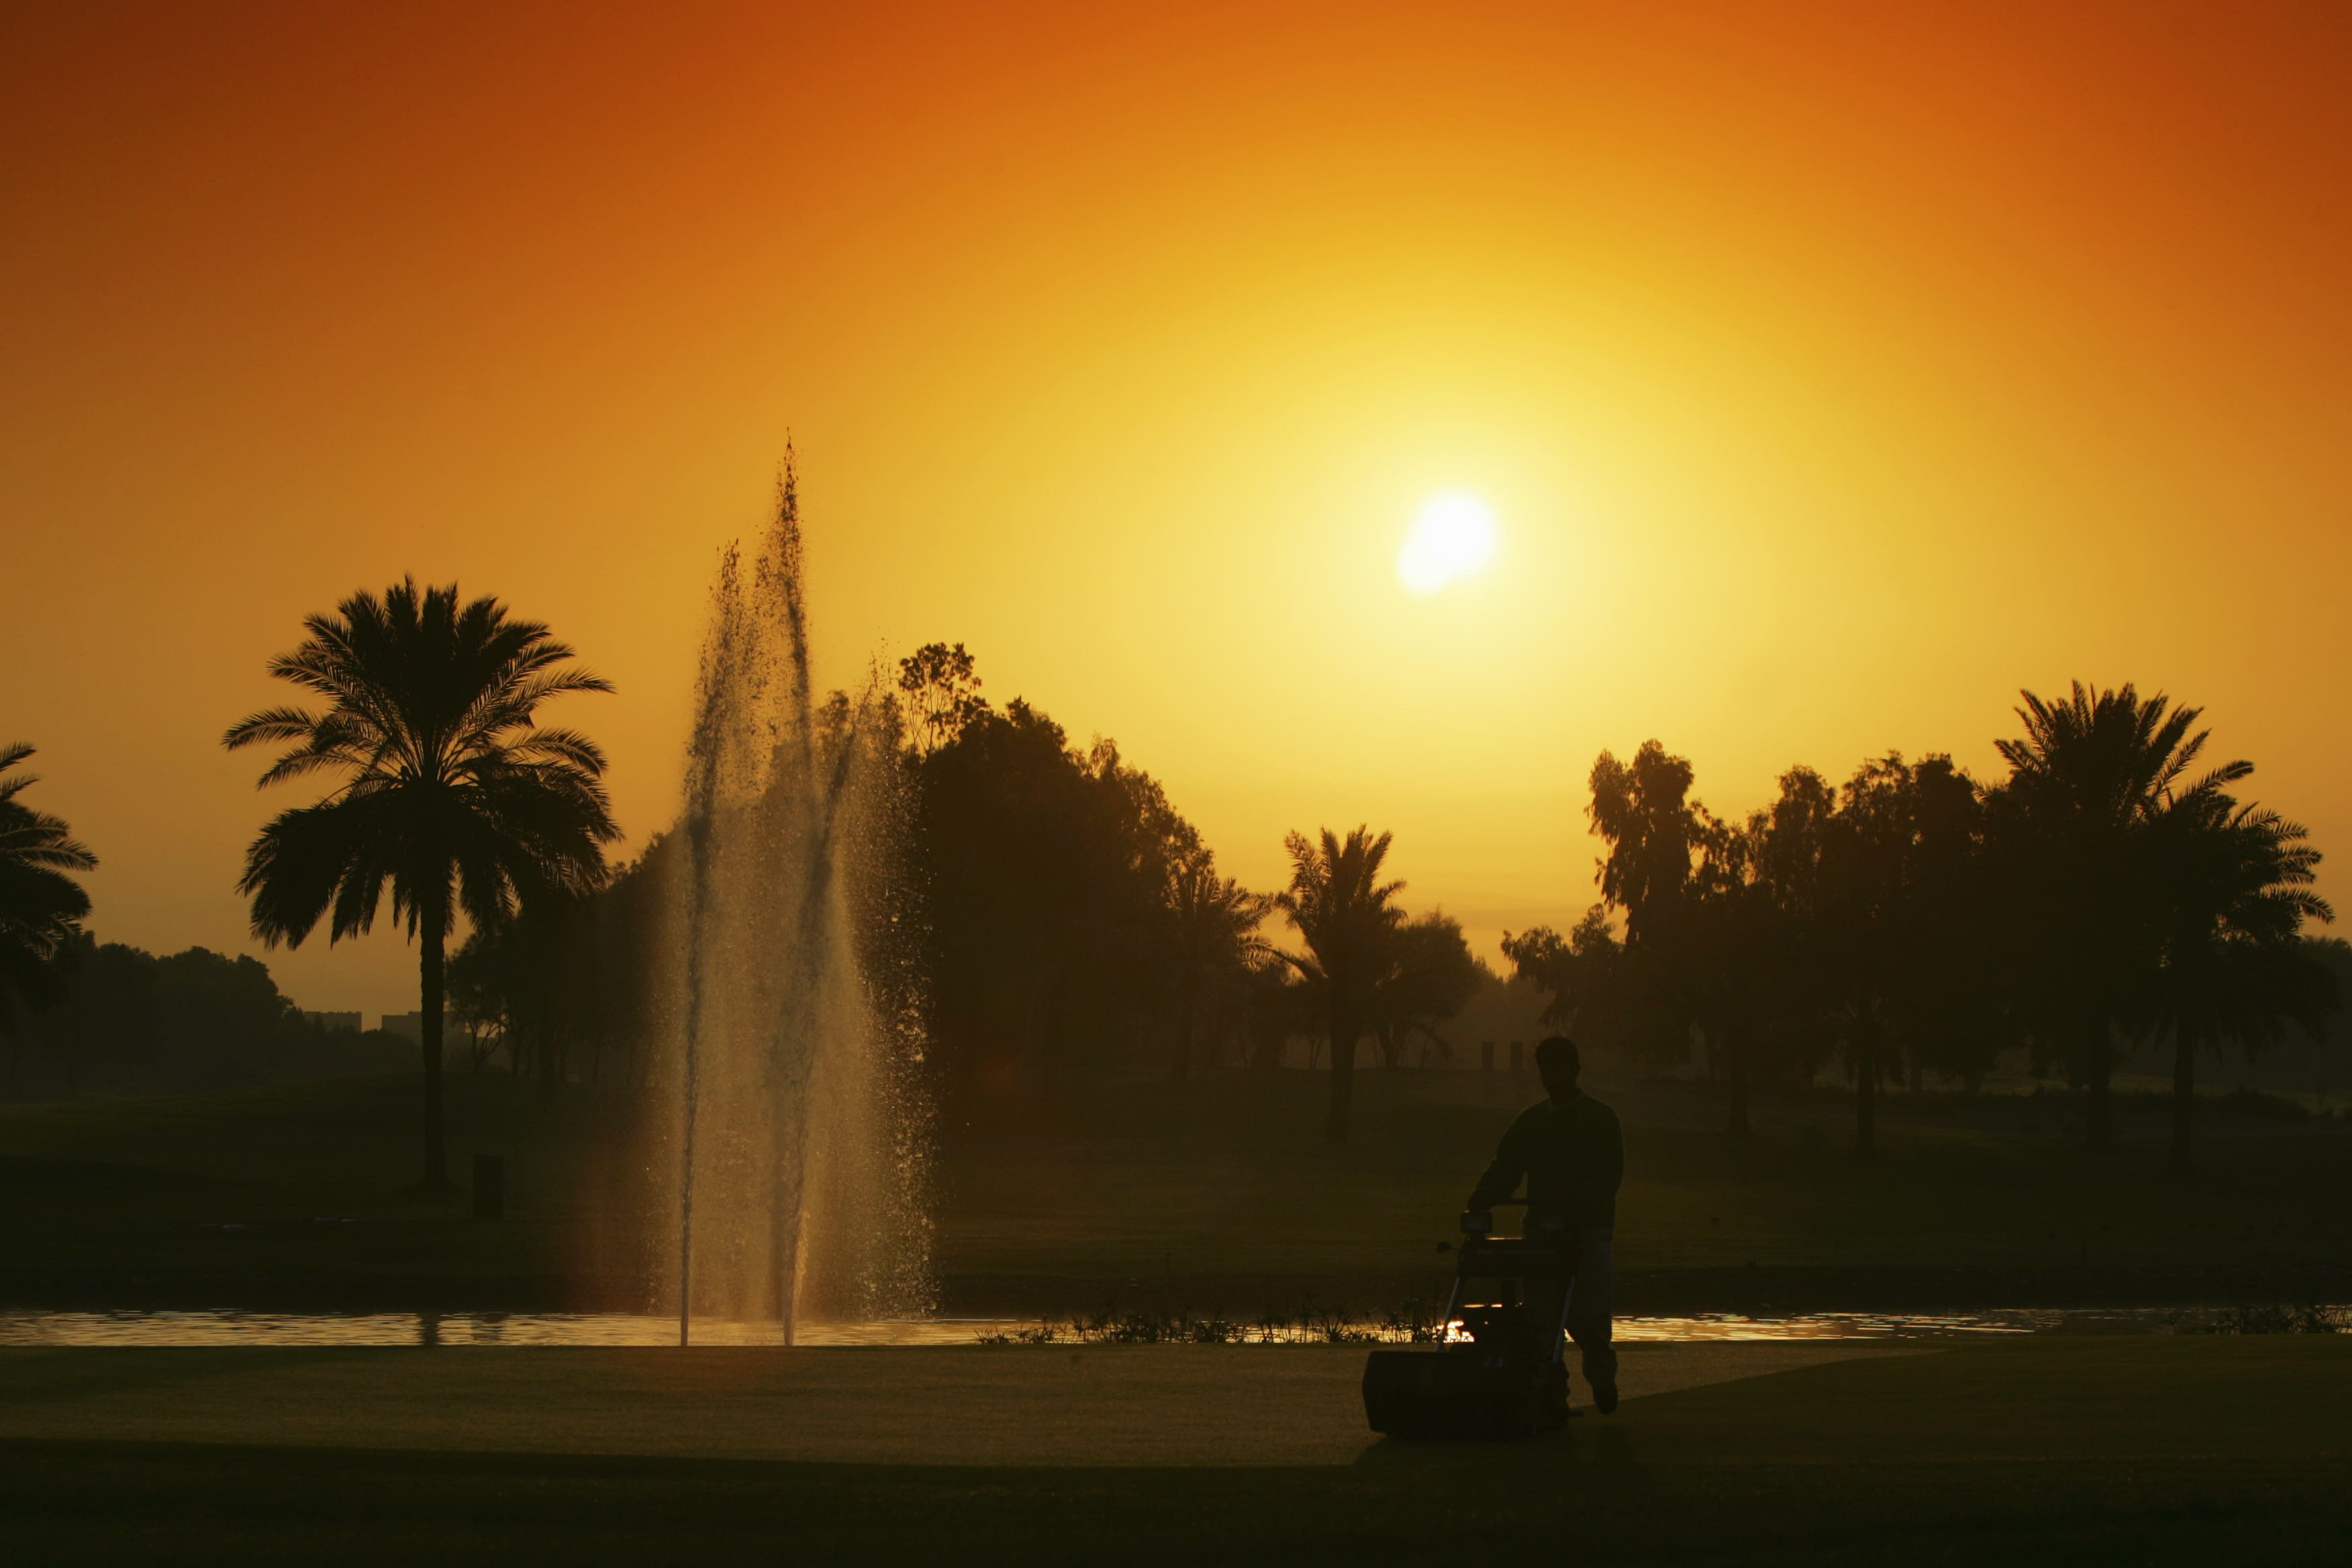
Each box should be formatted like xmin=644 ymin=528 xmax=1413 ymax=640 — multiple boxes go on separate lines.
xmin=654 ymin=458 xmax=932 ymax=1344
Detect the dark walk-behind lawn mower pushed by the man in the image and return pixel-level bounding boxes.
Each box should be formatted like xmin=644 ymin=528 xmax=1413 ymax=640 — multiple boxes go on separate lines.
xmin=1364 ymin=1199 xmax=1571 ymax=1436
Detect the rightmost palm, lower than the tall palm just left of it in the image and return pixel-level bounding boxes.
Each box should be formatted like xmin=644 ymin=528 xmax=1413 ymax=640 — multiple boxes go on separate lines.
xmin=2155 ymin=787 xmax=2335 ymax=1175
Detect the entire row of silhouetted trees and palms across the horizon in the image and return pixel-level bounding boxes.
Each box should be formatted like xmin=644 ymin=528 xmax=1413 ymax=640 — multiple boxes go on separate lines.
xmin=18 ymin=606 xmax=2347 ymax=1185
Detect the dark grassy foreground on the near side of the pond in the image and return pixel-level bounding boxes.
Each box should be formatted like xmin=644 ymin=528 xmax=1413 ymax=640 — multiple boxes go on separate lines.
xmin=0 ymin=1335 xmax=2352 ymax=1565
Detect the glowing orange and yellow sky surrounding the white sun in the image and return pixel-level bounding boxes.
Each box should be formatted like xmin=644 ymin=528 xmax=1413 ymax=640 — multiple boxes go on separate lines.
xmin=0 ymin=3 xmax=2352 ymax=1011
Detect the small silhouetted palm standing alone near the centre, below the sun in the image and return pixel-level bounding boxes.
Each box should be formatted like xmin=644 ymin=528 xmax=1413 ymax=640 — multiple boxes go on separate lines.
xmin=1275 ymin=828 xmax=1404 ymax=1142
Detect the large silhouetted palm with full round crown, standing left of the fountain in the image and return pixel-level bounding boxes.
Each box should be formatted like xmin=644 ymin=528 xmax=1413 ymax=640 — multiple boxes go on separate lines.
xmin=224 ymin=579 xmax=621 ymax=1189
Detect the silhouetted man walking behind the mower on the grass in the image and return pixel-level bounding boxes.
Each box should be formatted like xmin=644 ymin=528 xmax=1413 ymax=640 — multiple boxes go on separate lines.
xmin=1465 ymin=1034 xmax=1625 ymax=1415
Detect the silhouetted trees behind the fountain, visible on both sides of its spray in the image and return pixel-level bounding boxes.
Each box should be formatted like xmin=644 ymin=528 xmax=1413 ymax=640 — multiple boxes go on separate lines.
xmin=432 ymin=644 xmax=1491 ymax=1131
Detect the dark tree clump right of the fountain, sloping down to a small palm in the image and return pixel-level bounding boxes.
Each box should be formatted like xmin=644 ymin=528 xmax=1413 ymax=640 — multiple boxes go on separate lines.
xmin=875 ymin=644 xmax=1489 ymax=1136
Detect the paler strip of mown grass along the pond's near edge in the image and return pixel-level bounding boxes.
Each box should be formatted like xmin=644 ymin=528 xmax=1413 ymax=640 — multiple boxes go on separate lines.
xmin=0 ymin=1340 xmax=1917 ymax=1467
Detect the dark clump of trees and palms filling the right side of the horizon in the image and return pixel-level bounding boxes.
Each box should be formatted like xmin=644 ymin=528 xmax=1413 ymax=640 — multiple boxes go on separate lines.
xmin=1503 ymin=684 xmax=2335 ymax=1171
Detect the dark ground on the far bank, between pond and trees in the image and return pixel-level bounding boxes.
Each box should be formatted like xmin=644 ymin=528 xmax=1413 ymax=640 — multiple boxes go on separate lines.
xmin=0 ymin=1072 xmax=2352 ymax=1316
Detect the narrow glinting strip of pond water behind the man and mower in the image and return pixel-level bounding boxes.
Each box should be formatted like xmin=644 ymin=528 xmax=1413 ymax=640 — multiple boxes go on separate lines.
xmin=0 ymin=1307 xmax=2257 ymax=1347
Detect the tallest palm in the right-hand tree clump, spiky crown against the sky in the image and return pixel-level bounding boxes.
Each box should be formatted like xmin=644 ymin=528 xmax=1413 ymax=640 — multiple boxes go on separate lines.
xmin=1988 ymin=682 xmax=2253 ymax=1145
